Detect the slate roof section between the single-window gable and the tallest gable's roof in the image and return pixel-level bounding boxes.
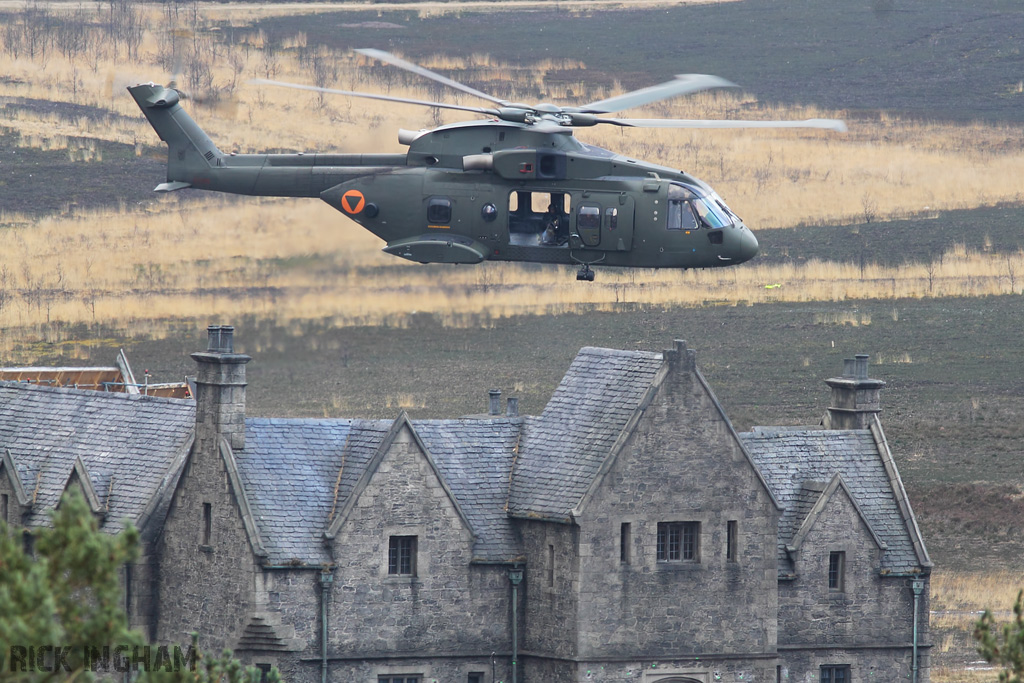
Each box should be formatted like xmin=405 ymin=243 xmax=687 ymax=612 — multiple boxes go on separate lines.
xmin=413 ymin=419 xmax=522 ymax=562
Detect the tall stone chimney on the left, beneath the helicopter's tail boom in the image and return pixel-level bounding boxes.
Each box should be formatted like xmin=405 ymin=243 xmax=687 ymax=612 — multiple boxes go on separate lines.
xmin=191 ymin=325 xmax=252 ymax=451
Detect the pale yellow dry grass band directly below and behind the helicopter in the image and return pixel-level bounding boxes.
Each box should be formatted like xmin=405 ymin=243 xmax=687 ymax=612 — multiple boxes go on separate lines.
xmin=0 ymin=196 xmax=1024 ymax=327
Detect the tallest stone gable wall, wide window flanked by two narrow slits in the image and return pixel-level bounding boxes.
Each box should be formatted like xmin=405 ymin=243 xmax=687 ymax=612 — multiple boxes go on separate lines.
xmin=578 ymin=356 xmax=778 ymax=680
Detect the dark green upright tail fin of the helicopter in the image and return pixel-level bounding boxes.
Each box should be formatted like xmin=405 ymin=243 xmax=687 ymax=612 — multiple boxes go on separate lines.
xmin=128 ymin=83 xmax=223 ymax=191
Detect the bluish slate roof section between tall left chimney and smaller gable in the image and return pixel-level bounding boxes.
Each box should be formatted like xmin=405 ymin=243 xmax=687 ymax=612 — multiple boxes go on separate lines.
xmin=234 ymin=418 xmax=391 ymax=565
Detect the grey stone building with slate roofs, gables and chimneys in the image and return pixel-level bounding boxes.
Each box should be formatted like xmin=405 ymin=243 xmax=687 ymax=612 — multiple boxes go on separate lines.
xmin=0 ymin=327 xmax=931 ymax=683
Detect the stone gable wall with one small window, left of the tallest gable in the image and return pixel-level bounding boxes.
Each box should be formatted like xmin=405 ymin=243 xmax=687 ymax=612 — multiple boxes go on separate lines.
xmin=329 ymin=428 xmax=511 ymax=680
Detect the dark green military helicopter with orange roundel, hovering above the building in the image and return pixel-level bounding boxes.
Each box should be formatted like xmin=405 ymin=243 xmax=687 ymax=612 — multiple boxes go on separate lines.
xmin=128 ymin=49 xmax=846 ymax=281
